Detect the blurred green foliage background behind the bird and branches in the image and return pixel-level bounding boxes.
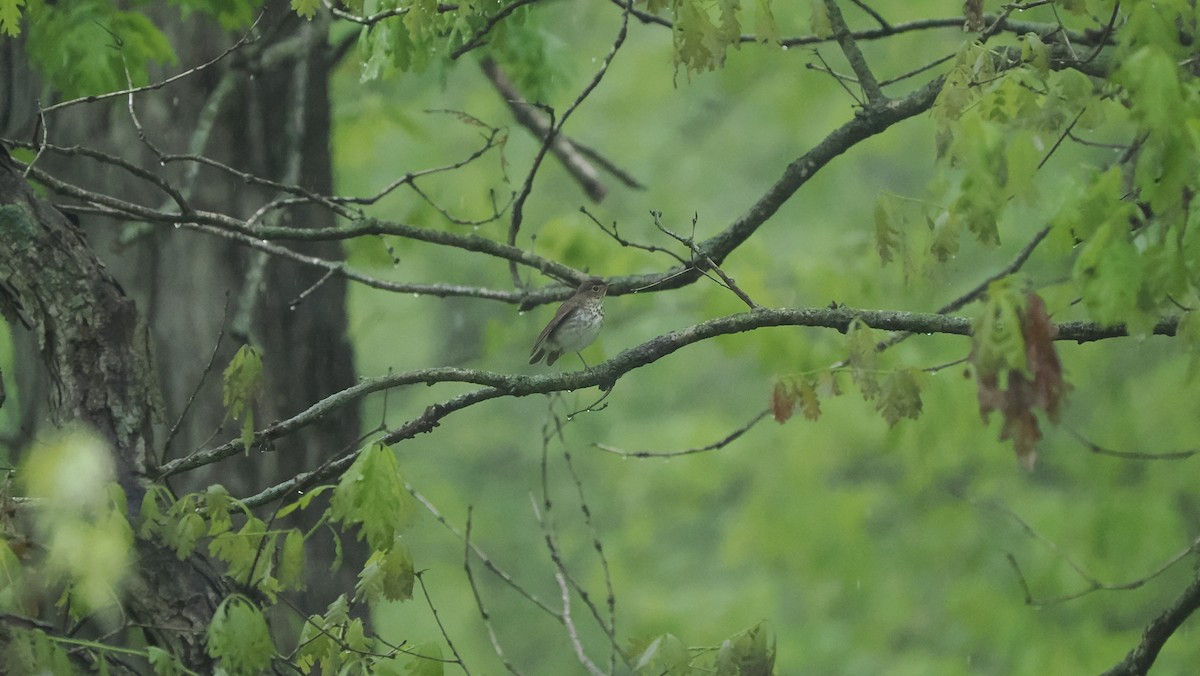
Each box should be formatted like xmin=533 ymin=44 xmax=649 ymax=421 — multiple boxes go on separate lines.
xmin=334 ymin=2 xmax=1200 ymax=675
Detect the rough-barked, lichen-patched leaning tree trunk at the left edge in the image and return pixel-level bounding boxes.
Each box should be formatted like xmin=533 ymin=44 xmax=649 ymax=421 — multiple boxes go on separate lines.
xmin=0 ymin=154 xmax=224 ymax=672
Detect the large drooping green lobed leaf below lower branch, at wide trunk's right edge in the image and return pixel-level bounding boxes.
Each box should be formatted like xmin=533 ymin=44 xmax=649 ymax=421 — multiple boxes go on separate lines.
xmin=329 ymin=443 xmax=419 ymax=551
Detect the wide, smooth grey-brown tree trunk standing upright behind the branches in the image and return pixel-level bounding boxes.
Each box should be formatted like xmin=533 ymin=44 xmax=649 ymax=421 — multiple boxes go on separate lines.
xmin=7 ymin=2 xmax=360 ymax=610
